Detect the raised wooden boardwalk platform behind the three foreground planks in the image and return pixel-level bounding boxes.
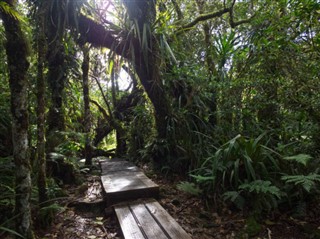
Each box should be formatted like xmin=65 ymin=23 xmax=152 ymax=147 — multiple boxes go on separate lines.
xmin=100 ymin=160 xmax=159 ymax=206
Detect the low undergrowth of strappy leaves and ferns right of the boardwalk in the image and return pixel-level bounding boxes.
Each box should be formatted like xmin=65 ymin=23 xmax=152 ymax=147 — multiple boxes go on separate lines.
xmin=178 ymin=134 xmax=320 ymax=215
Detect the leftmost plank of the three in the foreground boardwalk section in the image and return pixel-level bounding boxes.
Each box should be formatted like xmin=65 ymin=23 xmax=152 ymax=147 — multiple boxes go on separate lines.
xmin=115 ymin=206 xmax=146 ymax=239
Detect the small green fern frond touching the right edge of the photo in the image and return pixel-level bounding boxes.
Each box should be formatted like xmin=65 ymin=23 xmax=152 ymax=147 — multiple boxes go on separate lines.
xmin=281 ymin=173 xmax=320 ymax=193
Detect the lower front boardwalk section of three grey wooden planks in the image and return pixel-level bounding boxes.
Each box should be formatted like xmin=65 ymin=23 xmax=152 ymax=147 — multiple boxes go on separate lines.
xmin=114 ymin=199 xmax=191 ymax=239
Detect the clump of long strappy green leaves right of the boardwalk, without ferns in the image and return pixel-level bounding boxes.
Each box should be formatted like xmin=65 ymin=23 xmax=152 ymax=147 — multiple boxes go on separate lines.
xmin=191 ymin=134 xmax=279 ymax=192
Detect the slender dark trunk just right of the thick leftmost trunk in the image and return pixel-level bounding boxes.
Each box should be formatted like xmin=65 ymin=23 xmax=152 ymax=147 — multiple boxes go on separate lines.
xmin=37 ymin=1 xmax=48 ymax=203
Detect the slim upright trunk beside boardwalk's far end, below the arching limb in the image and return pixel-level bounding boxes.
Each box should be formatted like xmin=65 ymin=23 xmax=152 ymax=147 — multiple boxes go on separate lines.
xmin=82 ymin=46 xmax=92 ymax=166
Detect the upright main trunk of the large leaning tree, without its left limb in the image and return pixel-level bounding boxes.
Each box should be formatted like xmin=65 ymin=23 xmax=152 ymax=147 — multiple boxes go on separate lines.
xmin=124 ymin=0 xmax=170 ymax=140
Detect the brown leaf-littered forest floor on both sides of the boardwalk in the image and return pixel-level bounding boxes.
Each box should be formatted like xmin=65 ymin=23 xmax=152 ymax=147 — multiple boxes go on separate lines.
xmin=37 ymin=163 xmax=320 ymax=239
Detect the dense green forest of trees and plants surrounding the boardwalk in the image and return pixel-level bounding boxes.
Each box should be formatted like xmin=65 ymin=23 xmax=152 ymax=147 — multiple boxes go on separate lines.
xmin=0 ymin=0 xmax=320 ymax=238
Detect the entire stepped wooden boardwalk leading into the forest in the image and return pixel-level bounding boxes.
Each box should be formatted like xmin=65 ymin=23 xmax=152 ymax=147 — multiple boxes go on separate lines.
xmin=100 ymin=159 xmax=191 ymax=239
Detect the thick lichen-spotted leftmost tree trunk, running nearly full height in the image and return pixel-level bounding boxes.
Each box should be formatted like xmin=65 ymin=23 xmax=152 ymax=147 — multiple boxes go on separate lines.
xmin=1 ymin=1 xmax=33 ymax=238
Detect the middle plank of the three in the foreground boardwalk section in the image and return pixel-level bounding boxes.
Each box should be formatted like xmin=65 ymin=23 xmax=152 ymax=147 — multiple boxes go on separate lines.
xmin=129 ymin=203 xmax=169 ymax=239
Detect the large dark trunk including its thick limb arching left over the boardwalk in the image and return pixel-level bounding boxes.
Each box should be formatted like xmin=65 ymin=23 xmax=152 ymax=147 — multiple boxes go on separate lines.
xmin=69 ymin=0 xmax=172 ymax=163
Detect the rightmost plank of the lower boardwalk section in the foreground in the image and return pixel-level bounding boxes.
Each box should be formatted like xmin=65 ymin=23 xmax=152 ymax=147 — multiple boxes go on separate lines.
xmin=145 ymin=199 xmax=191 ymax=239
